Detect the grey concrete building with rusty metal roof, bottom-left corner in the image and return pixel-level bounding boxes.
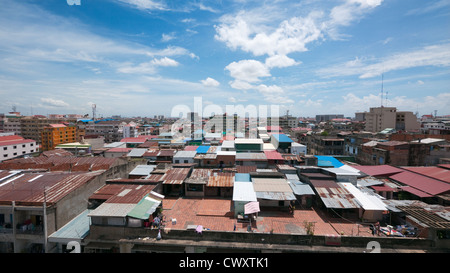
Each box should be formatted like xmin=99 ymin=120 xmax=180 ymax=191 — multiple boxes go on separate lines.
xmin=0 ymin=170 xmax=110 ymax=253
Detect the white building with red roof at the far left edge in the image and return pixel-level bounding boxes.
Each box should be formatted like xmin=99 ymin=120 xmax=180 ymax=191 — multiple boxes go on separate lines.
xmin=0 ymin=135 xmax=38 ymax=162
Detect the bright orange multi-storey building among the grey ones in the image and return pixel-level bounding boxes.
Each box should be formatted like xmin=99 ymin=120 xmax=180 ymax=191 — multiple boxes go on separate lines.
xmin=41 ymin=124 xmax=77 ymax=151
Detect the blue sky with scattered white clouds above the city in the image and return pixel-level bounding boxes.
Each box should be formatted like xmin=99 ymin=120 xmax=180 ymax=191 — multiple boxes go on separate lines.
xmin=0 ymin=0 xmax=450 ymax=117
